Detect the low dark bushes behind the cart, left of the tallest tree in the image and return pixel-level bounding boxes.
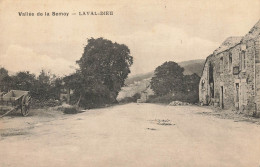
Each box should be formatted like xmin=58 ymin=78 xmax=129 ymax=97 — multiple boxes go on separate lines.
xmin=0 ymin=68 xmax=62 ymax=107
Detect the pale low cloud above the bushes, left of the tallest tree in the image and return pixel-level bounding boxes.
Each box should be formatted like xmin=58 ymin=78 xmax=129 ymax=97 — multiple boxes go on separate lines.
xmin=0 ymin=45 xmax=76 ymax=75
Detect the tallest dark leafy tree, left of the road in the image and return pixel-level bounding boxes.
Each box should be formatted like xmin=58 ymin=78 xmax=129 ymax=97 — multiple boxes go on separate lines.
xmin=72 ymin=38 xmax=133 ymax=105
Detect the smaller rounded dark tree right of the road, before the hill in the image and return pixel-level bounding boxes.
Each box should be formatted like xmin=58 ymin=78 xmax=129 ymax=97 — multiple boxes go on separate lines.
xmin=151 ymin=61 xmax=184 ymax=96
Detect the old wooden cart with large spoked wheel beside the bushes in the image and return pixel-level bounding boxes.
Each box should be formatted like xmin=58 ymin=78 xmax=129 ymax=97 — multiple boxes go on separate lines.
xmin=0 ymin=90 xmax=31 ymax=118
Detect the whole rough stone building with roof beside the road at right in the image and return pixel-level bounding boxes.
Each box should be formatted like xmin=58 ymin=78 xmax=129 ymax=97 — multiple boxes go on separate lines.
xmin=199 ymin=20 xmax=260 ymax=115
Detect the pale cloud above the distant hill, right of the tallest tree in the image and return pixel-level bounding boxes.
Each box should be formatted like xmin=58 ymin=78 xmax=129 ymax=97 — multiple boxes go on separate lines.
xmin=101 ymin=24 xmax=219 ymax=74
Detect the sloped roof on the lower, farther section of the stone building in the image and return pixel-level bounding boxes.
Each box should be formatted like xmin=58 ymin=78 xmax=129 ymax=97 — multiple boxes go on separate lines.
xmin=214 ymin=37 xmax=242 ymax=54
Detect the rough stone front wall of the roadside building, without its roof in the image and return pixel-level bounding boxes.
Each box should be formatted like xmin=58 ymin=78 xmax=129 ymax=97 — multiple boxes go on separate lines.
xmin=200 ymin=36 xmax=260 ymax=114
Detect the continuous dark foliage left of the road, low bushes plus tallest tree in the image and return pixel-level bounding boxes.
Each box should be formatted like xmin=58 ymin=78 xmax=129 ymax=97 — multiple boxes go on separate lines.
xmin=0 ymin=38 xmax=133 ymax=108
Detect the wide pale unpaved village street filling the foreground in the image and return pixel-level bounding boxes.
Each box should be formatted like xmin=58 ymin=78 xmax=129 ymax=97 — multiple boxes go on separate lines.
xmin=0 ymin=103 xmax=260 ymax=167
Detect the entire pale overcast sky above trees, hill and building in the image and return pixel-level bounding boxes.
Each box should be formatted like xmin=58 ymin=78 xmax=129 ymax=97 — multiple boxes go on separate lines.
xmin=0 ymin=0 xmax=260 ymax=75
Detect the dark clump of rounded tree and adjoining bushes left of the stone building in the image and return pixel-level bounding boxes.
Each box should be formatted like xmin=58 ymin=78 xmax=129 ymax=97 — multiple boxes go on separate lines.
xmin=148 ymin=62 xmax=200 ymax=103
